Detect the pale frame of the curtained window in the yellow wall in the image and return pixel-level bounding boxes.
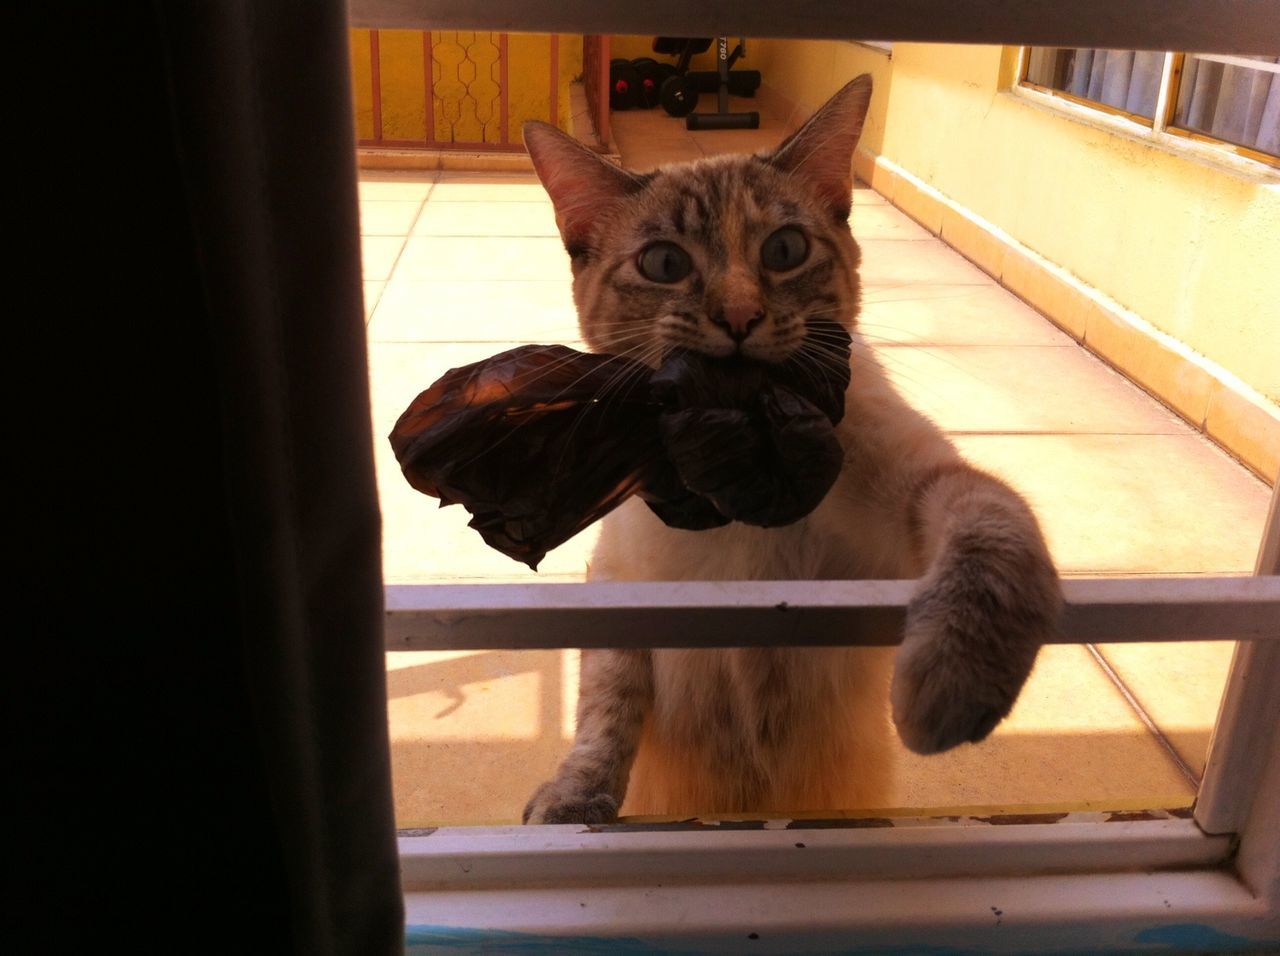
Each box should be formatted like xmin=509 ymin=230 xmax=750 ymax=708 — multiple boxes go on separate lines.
xmin=1009 ymin=49 xmax=1280 ymax=180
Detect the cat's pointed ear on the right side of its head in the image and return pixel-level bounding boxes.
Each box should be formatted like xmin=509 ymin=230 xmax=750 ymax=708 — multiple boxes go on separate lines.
xmin=765 ymin=73 xmax=872 ymax=220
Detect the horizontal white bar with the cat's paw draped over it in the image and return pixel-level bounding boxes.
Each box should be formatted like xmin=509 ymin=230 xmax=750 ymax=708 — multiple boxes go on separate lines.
xmin=387 ymin=577 xmax=1280 ymax=651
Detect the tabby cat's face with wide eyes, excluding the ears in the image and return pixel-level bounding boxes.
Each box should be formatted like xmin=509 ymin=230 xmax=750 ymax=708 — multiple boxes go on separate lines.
xmin=563 ymin=156 xmax=858 ymax=362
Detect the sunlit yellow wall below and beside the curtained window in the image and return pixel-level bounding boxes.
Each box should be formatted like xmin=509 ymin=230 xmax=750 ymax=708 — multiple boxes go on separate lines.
xmin=753 ymin=41 xmax=1280 ymax=401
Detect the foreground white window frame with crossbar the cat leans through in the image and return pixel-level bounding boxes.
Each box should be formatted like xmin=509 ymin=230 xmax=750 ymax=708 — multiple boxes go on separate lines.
xmin=352 ymin=0 xmax=1280 ymax=952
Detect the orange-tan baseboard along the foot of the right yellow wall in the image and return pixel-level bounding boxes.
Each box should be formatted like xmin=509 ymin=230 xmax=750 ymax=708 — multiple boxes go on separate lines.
xmin=854 ymin=150 xmax=1280 ymax=484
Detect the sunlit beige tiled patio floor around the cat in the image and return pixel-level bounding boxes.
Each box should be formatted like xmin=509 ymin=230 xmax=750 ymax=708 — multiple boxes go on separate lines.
xmin=361 ymin=101 xmax=1267 ymax=825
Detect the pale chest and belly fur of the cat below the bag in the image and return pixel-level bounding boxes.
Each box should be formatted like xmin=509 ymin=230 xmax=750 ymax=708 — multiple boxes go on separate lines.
xmin=590 ymin=376 xmax=936 ymax=813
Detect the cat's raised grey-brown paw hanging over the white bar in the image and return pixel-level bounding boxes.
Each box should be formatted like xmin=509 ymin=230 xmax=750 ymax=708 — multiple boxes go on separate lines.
xmin=890 ymin=573 xmax=1056 ymax=754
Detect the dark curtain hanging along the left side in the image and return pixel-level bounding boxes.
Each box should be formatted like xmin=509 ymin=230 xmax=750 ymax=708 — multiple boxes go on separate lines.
xmin=16 ymin=0 xmax=403 ymax=955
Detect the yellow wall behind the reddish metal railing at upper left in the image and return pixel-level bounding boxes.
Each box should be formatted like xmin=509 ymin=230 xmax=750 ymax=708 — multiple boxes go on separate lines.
xmin=351 ymin=29 xmax=582 ymax=145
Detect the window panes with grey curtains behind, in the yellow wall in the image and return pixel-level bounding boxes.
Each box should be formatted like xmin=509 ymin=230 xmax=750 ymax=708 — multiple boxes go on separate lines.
xmin=1020 ymin=46 xmax=1280 ymax=165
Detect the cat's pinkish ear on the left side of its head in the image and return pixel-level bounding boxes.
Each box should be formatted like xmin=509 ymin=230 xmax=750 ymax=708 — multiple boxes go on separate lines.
xmin=525 ymin=119 xmax=644 ymax=259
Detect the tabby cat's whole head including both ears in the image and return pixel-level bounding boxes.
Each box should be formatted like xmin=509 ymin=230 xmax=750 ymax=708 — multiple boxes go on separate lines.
xmin=526 ymin=78 xmax=870 ymax=365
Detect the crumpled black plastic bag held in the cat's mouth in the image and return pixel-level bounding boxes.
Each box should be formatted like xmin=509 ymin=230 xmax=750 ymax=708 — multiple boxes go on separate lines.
xmin=390 ymin=323 xmax=850 ymax=570
